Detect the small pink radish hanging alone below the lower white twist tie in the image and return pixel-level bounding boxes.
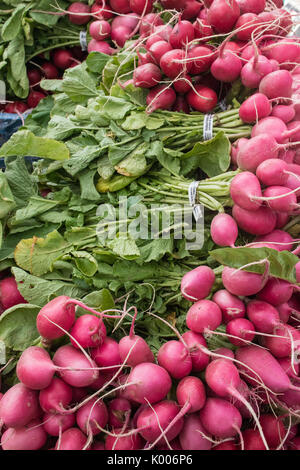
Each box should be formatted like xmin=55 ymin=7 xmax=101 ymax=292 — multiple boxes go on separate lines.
xmin=210 ymin=214 xmax=238 ymax=248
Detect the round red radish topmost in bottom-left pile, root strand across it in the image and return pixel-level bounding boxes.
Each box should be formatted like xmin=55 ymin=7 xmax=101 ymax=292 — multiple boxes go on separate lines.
xmin=36 ymin=295 xmax=75 ymax=340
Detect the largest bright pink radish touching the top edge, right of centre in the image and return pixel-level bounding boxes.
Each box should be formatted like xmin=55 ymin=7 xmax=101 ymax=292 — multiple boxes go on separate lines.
xmin=207 ymin=0 xmax=240 ymax=33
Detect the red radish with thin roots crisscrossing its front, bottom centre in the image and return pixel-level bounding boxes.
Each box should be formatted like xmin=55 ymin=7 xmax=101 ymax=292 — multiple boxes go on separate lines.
xmin=137 ymin=400 xmax=183 ymax=445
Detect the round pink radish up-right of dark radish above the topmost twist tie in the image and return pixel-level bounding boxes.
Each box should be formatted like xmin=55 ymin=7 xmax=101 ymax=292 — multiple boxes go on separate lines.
xmin=210 ymin=50 xmax=245 ymax=83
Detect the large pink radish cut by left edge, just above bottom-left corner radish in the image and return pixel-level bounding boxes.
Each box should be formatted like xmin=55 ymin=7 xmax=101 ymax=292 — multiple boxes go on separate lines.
xmin=0 ymin=383 xmax=41 ymax=428
